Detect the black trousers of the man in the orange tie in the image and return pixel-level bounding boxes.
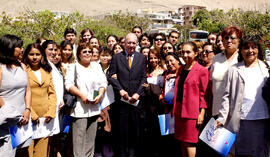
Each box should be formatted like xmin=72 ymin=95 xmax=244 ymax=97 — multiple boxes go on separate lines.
xmin=111 ymin=100 xmax=142 ymax=157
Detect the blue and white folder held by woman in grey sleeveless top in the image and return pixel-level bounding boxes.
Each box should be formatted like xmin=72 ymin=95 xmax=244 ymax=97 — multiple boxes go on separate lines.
xmin=9 ymin=118 xmax=33 ymax=149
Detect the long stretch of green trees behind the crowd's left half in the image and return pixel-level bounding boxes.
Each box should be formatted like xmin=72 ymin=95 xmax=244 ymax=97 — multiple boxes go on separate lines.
xmin=0 ymin=10 xmax=149 ymax=45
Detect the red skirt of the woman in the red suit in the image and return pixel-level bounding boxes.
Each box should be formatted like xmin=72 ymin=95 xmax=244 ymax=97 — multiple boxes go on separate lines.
xmin=174 ymin=102 xmax=199 ymax=143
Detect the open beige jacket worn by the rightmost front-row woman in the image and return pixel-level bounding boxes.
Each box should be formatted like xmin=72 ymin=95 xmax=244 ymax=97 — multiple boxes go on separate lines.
xmin=217 ymin=60 xmax=269 ymax=132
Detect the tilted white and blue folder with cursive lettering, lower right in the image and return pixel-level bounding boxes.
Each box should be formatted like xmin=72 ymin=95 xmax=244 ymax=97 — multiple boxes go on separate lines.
xmin=199 ymin=118 xmax=236 ymax=156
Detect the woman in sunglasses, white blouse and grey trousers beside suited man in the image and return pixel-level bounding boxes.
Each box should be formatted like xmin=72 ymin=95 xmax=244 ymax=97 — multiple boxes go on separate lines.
xmin=65 ymin=43 xmax=107 ymax=157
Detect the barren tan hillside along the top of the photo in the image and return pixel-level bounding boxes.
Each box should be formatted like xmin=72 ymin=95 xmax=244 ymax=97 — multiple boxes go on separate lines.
xmin=0 ymin=0 xmax=270 ymax=16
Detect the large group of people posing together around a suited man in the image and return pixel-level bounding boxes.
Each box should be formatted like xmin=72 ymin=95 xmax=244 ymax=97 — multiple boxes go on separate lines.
xmin=0 ymin=26 xmax=270 ymax=157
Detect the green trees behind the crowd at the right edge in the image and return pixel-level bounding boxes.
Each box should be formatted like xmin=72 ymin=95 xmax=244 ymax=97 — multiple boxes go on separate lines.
xmin=193 ymin=9 xmax=270 ymax=45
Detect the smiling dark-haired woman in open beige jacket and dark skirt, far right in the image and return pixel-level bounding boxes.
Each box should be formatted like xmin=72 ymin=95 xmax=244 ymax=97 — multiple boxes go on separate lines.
xmin=217 ymin=37 xmax=269 ymax=157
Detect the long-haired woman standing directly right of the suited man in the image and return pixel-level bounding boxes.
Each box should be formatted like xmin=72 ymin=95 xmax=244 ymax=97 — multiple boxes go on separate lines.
xmin=142 ymin=47 xmax=165 ymax=156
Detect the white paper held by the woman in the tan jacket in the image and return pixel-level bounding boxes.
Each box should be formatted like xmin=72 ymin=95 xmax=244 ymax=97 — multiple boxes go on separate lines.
xmin=32 ymin=117 xmax=54 ymax=139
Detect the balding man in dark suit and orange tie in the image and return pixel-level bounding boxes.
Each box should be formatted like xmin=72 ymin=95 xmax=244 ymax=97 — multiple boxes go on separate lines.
xmin=108 ymin=33 xmax=146 ymax=157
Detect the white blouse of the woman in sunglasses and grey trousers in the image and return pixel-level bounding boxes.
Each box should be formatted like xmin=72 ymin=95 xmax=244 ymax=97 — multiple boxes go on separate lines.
xmin=65 ymin=62 xmax=107 ymax=118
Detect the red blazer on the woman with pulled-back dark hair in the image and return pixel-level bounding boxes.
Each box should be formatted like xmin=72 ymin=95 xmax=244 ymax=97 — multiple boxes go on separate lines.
xmin=173 ymin=62 xmax=209 ymax=119
